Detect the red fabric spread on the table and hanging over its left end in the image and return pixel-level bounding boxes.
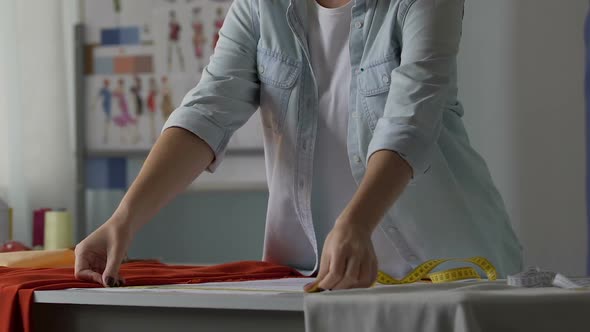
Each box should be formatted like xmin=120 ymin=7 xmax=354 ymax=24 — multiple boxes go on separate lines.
xmin=0 ymin=261 xmax=302 ymax=332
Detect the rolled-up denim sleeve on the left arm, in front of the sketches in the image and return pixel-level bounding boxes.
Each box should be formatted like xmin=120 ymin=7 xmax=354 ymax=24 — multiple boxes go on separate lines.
xmin=162 ymin=0 xmax=260 ymax=172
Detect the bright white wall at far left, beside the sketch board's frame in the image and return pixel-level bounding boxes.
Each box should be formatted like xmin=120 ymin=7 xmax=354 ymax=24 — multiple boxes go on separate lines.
xmin=0 ymin=0 xmax=75 ymax=243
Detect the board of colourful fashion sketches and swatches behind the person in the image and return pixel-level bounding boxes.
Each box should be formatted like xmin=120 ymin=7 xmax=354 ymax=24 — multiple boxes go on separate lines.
xmin=83 ymin=0 xmax=263 ymax=155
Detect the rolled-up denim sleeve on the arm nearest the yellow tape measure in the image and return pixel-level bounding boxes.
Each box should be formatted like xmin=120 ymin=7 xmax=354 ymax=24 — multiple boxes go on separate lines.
xmin=367 ymin=0 xmax=464 ymax=177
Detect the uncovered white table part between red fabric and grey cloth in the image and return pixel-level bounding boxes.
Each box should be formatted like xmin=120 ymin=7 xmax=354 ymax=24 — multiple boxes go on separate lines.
xmin=32 ymin=289 xmax=305 ymax=332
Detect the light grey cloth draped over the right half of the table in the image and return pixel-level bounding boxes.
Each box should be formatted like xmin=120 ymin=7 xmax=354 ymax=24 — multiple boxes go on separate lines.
xmin=305 ymin=281 xmax=590 ymax=332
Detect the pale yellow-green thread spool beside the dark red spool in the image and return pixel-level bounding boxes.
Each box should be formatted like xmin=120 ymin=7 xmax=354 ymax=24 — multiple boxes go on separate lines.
xmin=44 ymin=210 xmax=73 ymax=250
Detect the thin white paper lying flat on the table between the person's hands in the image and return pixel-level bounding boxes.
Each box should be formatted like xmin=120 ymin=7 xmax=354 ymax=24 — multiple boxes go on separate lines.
xmin=70 ymin=278 xmax=315 ymax=295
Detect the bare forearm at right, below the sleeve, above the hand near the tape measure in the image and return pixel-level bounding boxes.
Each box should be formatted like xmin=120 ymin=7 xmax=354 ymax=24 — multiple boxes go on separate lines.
xmin=339 ymin=150 xmax=412 ymax=232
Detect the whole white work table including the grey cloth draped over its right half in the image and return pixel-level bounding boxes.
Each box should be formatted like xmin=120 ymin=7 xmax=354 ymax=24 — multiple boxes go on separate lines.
xmin=33 ymin=281 xmax=590 ymax=332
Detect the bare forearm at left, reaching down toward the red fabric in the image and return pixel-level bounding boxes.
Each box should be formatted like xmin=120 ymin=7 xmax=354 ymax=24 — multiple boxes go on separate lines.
xmin=112 ymin=128 xmax=214 ymax=232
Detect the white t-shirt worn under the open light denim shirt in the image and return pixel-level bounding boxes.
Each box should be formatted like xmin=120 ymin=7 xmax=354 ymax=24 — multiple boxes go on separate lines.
xmin=307 ymin=0 xmax=410 ymax=277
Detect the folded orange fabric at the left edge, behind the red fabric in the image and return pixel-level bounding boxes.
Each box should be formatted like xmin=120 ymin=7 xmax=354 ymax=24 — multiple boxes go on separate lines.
xmin=0 ymin=249 xmax=75 ymax=268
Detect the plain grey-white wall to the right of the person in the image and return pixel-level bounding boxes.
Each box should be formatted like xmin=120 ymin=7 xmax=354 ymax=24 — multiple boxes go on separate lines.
xmin=459 ymin=0 xmax=588 ymax=274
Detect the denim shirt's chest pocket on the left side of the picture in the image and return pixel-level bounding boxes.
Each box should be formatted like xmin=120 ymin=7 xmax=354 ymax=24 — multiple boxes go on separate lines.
xmin=257 ymin=48 xmax=301 ymax=133
